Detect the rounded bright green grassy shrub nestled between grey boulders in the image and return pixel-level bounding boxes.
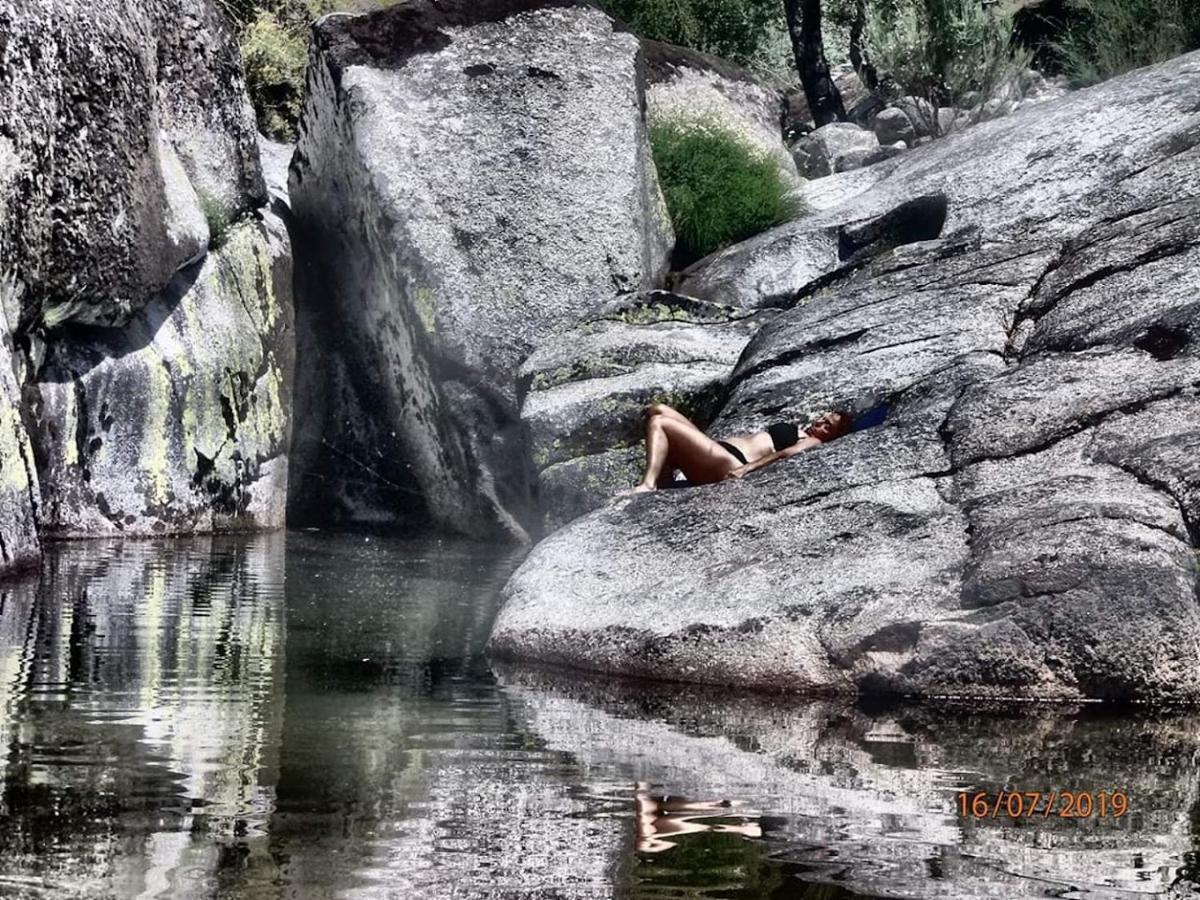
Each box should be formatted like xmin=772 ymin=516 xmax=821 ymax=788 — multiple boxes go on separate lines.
xmin=650 ymin=119 xmax=804 ymax=265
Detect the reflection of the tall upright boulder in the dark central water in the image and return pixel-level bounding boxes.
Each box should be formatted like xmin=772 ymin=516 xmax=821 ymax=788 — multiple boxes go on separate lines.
xmin=270 ymin=535 xmax=631 ymax=898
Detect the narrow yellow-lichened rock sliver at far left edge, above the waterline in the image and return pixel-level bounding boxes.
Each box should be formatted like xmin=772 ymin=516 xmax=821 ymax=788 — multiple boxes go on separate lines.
xmin=0 ymin=275 xmax=38 ymax=578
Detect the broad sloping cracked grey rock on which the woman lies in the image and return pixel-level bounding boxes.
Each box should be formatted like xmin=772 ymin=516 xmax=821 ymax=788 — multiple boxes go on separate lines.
xmin=492 ymin=55 xmax=1200 ymax=701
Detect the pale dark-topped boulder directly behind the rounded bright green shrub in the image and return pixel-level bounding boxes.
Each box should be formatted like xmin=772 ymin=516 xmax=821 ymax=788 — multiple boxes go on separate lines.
xmin=642 ymin=41 xmax=802 ymax=187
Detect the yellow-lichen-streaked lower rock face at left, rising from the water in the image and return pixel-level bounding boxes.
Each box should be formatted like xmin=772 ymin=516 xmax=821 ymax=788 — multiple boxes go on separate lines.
xmin=34 ymin=214 xmax=295 ymax=538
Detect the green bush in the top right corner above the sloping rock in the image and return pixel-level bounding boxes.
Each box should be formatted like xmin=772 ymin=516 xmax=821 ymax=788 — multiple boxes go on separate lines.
xmin=1055 ymin=0 xmax=1200 ymax=85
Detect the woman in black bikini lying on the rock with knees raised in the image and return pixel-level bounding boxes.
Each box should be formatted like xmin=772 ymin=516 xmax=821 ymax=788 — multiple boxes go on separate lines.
xmin=626 ymin=403 xmax=853 ymax=493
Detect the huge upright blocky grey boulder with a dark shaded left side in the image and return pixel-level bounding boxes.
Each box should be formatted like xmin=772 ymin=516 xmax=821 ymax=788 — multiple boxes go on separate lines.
xmin=290 ymin=0 xmax=671 ymax=538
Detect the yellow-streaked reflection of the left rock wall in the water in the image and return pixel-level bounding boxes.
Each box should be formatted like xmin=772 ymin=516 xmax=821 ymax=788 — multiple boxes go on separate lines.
xmin=0 ymin=536 xmax=283 ymax=895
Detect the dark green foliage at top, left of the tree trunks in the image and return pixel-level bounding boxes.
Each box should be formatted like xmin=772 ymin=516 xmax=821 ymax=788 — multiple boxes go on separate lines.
xmin=598 ymin=0 xmax=781 ymax=65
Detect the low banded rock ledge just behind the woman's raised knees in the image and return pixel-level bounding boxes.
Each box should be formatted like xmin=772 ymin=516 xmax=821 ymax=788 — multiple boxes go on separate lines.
xmin=521 ymin=290 xmax=773 ymax=527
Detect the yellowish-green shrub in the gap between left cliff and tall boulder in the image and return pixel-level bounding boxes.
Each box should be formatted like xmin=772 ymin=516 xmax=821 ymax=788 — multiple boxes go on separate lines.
xmin=241 ymin=12 xmax=308 ymax=142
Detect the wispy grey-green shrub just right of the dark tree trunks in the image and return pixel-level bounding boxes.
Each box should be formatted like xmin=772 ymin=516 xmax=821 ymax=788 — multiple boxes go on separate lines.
xmin=866 ymin=0 xmax=1032 ymax=106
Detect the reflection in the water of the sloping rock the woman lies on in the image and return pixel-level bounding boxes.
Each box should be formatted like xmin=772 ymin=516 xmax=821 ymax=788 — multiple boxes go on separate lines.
xmin=500 ymin=667 xmax=1200 ymax=900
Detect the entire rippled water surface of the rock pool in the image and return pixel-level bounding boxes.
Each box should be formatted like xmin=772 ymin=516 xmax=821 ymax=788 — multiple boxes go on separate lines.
xmin=0 ymin=533 xmax=1200 ymax=900
